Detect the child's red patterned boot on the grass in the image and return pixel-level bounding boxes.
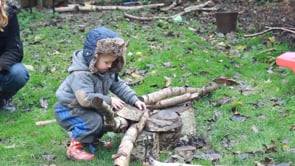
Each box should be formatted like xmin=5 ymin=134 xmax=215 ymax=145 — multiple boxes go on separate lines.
xmin=66 ymin=138 xmax=95 ymax=160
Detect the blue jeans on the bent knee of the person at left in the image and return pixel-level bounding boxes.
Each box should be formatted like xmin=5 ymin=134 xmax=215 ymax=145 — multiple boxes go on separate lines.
xmin=0 ymin=63 xmax=30 ymax=99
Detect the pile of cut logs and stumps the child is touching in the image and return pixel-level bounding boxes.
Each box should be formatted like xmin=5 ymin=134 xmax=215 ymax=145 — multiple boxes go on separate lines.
xmin=36 ymin=77 xmax=238 ymax=166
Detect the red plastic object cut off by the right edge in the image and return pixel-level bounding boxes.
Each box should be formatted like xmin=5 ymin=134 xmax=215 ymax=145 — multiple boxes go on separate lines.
xmin=276 ymin=52 xmax=295 ymax=73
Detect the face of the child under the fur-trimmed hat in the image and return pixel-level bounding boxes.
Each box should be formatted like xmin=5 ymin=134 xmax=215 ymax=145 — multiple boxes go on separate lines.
xmin=95 ymin=54 xmax=117 ymax=73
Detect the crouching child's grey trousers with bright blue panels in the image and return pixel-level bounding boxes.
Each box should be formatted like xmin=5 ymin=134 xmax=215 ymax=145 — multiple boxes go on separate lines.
xmin=54 ymin=104 xmax=104 ymax=143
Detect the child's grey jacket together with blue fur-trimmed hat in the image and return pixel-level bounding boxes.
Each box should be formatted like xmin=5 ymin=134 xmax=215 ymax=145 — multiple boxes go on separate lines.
xmin=56 ymin=27 xmax=139 ymax=108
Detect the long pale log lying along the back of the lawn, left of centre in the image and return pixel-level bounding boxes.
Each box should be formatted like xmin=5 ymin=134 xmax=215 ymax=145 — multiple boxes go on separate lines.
xmin=55 ymin=3 xmax=165 ymax=12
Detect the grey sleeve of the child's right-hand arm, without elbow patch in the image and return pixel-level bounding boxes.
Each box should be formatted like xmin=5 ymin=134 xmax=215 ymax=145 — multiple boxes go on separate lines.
xmin=110 ymin=78 xmax=139 ymax=105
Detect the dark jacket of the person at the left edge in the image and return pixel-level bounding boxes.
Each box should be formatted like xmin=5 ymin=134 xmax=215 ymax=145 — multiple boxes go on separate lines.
xmin=0 ymin=6 xmax=23 ymax=70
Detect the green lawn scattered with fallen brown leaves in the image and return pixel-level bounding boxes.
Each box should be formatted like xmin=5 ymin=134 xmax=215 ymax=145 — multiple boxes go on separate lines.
xmin=0 ymin=7 xmax=295 ymax=166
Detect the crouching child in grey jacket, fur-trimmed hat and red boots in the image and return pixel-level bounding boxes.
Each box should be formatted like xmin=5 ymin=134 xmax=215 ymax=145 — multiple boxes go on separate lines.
xmin=54 ymin=27 xmax=146 ymax=160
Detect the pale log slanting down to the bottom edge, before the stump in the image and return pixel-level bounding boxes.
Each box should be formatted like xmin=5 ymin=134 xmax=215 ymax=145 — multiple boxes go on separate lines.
xmin=112 ymin=110 xmax=149 ymax=166
